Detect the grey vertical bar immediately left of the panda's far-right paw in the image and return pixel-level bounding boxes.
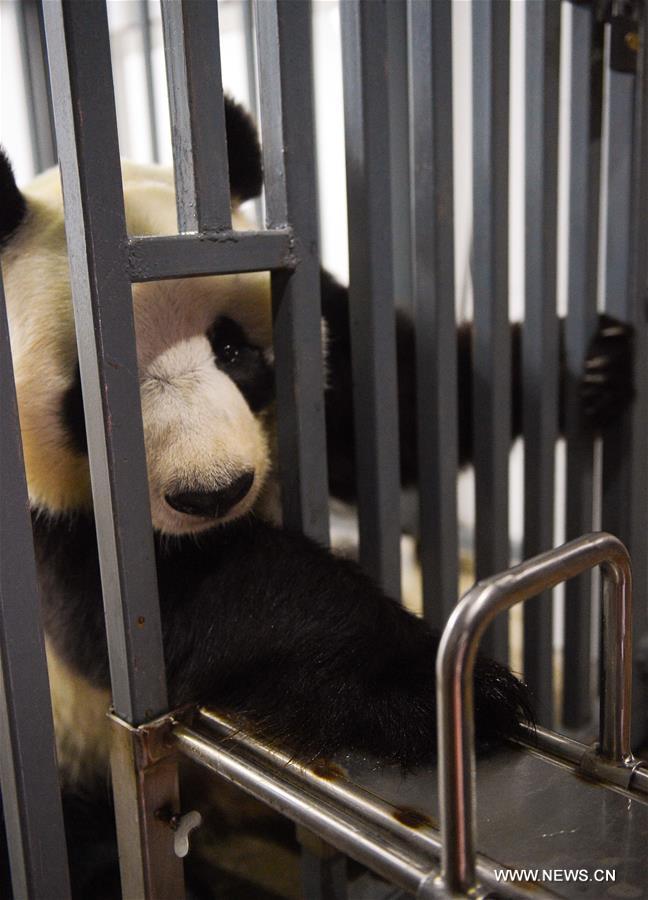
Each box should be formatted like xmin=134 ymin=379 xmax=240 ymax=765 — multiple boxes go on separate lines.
xmin=563 ymin=3 xmax=601 ymax=728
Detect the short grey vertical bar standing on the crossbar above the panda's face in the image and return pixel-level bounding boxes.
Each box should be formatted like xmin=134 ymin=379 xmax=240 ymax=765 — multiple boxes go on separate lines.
xmin=162 ymin=0 xmax=232 ymax=232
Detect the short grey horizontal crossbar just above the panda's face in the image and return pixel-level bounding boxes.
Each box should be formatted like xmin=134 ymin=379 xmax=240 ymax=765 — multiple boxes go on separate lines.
xmin=128 ymin=228 xmax=296 ymax=282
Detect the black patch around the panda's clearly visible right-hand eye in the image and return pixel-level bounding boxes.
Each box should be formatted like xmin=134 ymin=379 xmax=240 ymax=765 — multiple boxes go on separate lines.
xmin=207 ymin=316 xmax=274 ymax=412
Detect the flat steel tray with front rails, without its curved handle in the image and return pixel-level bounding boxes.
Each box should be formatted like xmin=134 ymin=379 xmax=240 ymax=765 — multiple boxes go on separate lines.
xmin=175 ymin=710 xmax=648 ymax=898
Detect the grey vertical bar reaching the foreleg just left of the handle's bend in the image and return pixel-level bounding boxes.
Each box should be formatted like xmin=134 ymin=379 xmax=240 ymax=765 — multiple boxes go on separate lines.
xmin=409 ymin=0 xmax=458 ymax=627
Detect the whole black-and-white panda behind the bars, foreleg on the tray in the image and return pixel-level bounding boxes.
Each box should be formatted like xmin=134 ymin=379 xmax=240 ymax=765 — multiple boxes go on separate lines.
xmin=0 ymin=95 xmax=631 ymax=897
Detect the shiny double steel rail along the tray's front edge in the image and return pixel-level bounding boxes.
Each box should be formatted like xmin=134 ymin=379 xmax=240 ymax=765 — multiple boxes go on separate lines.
xmin=173 ymin=709 xmax=546 ymax=898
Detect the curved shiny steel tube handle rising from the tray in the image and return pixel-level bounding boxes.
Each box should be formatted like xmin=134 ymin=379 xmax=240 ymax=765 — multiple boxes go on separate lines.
xmin=437 ymin=532 xmax=632 ymax=892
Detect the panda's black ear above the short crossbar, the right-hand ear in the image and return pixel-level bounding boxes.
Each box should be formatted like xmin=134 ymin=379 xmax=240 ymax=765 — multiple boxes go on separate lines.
xmin=225 ymin=96 xmax=263 ymax=203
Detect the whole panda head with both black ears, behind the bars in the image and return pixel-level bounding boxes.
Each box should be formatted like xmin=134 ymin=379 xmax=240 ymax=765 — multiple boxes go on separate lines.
xmin=0 ymin=101 xmax=280 ymax=534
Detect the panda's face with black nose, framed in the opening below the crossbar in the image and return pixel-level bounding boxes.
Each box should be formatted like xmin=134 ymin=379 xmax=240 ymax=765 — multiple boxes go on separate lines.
xmin=134 ymin=275 xmax=273 ymax=534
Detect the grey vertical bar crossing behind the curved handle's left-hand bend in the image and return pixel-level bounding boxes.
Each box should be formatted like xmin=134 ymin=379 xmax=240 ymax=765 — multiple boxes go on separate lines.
xmin=472 ymin=0 xmax=512 ymax=662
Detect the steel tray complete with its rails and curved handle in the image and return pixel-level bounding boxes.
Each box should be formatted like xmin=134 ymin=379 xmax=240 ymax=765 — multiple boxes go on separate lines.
xmin=170 ymin=534 xmax=648 ymax=898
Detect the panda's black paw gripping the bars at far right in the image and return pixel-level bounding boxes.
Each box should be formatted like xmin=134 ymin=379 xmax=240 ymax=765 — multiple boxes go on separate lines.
xmin=580 ymin=313 xmax=634 ymax=431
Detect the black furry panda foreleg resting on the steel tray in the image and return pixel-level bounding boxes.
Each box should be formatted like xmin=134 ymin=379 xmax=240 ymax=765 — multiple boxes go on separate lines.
xmin=159 ymin=520 xmax=530 ymax=766
